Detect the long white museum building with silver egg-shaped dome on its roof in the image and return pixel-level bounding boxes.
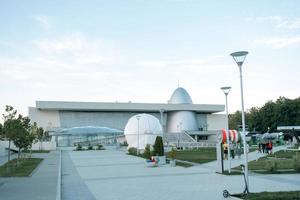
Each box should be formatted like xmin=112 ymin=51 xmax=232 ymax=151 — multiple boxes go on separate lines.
xmin=29 ymin=87 xmax=227 ymax=145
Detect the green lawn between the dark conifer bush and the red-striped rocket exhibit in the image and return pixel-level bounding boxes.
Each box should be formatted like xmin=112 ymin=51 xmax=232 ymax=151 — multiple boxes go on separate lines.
xmin=167 ymin=147 xmax=217 ymax=163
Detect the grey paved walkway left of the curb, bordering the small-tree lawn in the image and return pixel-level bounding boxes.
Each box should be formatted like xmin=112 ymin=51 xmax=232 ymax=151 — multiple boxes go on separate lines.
xmin=0 ymin=151 xmax=59 ymax=200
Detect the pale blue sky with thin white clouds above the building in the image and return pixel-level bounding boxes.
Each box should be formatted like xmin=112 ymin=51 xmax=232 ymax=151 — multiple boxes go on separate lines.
xmin=0 ymin=0 xmax=300 ymax=118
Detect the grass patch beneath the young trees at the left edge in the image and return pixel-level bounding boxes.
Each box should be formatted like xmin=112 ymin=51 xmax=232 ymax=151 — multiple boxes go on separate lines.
xmin=0 ymin=158 xmax=43 ymax=177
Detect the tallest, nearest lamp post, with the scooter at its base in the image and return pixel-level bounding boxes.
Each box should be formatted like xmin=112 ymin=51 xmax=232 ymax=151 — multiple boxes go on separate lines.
xmin=230 ymin=51 xmax=249 ymax=192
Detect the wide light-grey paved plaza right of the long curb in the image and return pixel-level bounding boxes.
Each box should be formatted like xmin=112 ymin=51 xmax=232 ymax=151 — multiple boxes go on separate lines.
xmin=63 ymin=150 xmax=300 ymax=200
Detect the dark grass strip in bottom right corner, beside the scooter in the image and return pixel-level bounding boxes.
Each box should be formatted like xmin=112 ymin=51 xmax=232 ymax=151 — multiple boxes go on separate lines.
xmin=246 ymin=191 xmax=300 ymax=200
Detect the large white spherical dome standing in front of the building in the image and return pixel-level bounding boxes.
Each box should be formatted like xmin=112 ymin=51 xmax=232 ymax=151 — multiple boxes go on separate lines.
xmin=124 ymin=114 xmax=162 ymax=149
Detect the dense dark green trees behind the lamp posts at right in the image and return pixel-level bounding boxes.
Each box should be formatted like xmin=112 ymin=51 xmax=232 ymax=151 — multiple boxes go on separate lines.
xmin=229 ymin=97 xmax=300 ymax=132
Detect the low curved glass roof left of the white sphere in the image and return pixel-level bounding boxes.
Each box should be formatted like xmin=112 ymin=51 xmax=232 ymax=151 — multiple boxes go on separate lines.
xmin=58 ymin=126 xmax=123 ymax=136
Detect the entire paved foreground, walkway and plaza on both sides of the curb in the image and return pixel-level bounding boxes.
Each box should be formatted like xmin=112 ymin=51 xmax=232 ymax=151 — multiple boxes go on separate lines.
xmin=0 ymin=149 xmax=300 ymax=200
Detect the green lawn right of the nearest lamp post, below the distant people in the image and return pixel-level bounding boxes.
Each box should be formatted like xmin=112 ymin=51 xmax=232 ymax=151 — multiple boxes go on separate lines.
xmin=234 ymin=150 xmax=300 ymax=173
